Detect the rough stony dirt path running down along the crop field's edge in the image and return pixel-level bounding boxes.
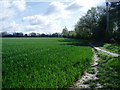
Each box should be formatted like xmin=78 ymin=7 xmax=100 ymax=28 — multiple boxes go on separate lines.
xmin=74 ymin=49 xmax=101 ymax=88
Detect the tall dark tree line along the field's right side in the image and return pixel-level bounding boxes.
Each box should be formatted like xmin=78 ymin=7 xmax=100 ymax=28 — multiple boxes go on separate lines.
xmin=62 ymin=2 xmax=120 ymax=44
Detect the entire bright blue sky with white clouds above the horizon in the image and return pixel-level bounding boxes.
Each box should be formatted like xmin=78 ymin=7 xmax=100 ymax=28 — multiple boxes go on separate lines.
xmin=0 ymin=0 xmax=105 ymax=34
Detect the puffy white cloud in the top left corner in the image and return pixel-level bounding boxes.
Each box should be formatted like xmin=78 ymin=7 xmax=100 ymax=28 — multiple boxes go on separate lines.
xmin=0 ymin=0 xmax=26 ymax=20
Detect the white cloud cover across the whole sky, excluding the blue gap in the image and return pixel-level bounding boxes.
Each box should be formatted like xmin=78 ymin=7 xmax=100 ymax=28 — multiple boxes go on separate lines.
xmin=0 ymin=0 xmax=104 ymax=33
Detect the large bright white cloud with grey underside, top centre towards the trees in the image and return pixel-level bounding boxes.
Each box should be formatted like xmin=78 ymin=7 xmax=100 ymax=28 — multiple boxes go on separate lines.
xmin=44 ymin=0 xmax=105 ymax=19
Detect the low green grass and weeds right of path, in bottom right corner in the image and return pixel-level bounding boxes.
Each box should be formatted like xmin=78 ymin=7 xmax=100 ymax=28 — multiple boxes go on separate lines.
xmin=98 ymin=54 xmax=120 ymax=88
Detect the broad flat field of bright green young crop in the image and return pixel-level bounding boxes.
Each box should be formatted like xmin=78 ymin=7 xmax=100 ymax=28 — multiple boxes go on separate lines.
xmin=2 ymin=38 xmax=93 ymax=88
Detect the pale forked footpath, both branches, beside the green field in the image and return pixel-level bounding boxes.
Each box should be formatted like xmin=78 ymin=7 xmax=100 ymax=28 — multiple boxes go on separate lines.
xmin=72 ymin=43 xmax=120 ymax=88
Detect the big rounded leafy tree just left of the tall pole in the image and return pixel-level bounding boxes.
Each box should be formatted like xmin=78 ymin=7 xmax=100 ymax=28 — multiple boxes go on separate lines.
xmin=75 ymin=7 xmax=106 ymax=40
